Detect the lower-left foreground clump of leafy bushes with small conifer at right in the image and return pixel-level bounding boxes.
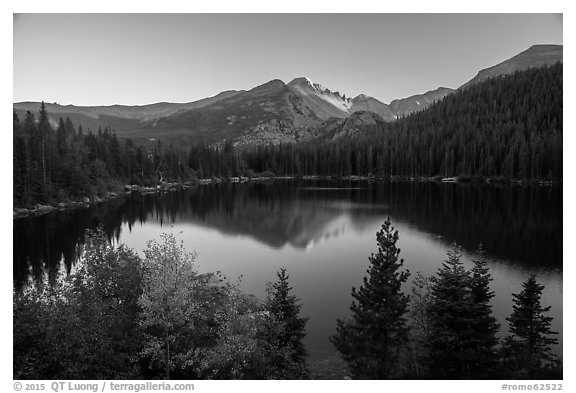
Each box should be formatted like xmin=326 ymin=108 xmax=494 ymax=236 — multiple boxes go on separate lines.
xmin=13 ymin=230 xmax=308 ymax=379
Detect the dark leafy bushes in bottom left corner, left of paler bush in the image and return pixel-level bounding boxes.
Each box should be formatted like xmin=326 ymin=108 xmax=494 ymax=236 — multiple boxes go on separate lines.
xmin=13 ymin=231 xmax=141 ymax=379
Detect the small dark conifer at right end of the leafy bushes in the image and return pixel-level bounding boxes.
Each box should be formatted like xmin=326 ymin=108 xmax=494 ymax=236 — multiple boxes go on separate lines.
xmin=267 ymin=268 xmax=308 ymax=365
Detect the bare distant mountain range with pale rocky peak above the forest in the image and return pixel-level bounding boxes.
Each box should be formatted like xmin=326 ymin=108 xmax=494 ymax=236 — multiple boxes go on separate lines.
xmin=14 ymin=45 xmax=563 ymax=145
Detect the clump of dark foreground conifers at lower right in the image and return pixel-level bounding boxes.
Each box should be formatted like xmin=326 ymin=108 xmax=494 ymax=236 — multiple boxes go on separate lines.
xmin=331 ymin=220 xmax=562 ymax=379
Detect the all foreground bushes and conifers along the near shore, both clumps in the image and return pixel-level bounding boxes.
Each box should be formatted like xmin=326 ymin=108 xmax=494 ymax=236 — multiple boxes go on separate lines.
xmin=13 ymin=219 xmax=562 ymax=379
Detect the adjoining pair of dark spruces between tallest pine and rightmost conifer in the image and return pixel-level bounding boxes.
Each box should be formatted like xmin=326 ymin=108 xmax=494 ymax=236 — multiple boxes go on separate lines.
xmin=428 ymin=244 xmax=500 ymax=379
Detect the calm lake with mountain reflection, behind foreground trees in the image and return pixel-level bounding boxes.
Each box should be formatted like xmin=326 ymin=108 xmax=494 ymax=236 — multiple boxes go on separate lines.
xmin=13 ymin=181 xmax=563 ymax=356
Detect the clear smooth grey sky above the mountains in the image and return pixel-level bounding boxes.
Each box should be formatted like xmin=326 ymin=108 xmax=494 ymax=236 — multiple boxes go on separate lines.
xmin=13 ymin=14 xmax=563 ymax=105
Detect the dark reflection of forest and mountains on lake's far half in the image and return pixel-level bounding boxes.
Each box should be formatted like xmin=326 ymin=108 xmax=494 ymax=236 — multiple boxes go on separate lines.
xmin=13 ymin=181 xmax=562 ymax=288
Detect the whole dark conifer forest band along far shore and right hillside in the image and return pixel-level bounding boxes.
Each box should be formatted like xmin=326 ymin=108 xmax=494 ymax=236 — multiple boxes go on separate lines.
xmin=13 ymin=64 xmax=562 ymax=206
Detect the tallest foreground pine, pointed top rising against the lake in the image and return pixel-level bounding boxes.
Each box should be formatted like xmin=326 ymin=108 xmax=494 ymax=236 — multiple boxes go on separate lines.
xmin=330 ymin=219 xmax=409 ymax=379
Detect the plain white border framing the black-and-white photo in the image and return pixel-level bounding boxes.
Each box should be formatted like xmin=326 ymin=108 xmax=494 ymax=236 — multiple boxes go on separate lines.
xmin=0 ymin=0 xmax=576 ymax=393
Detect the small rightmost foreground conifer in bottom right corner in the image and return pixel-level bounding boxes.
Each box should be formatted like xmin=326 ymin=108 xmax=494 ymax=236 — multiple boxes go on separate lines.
xmin=502 ymin=274 xmax=558 ymax=378
